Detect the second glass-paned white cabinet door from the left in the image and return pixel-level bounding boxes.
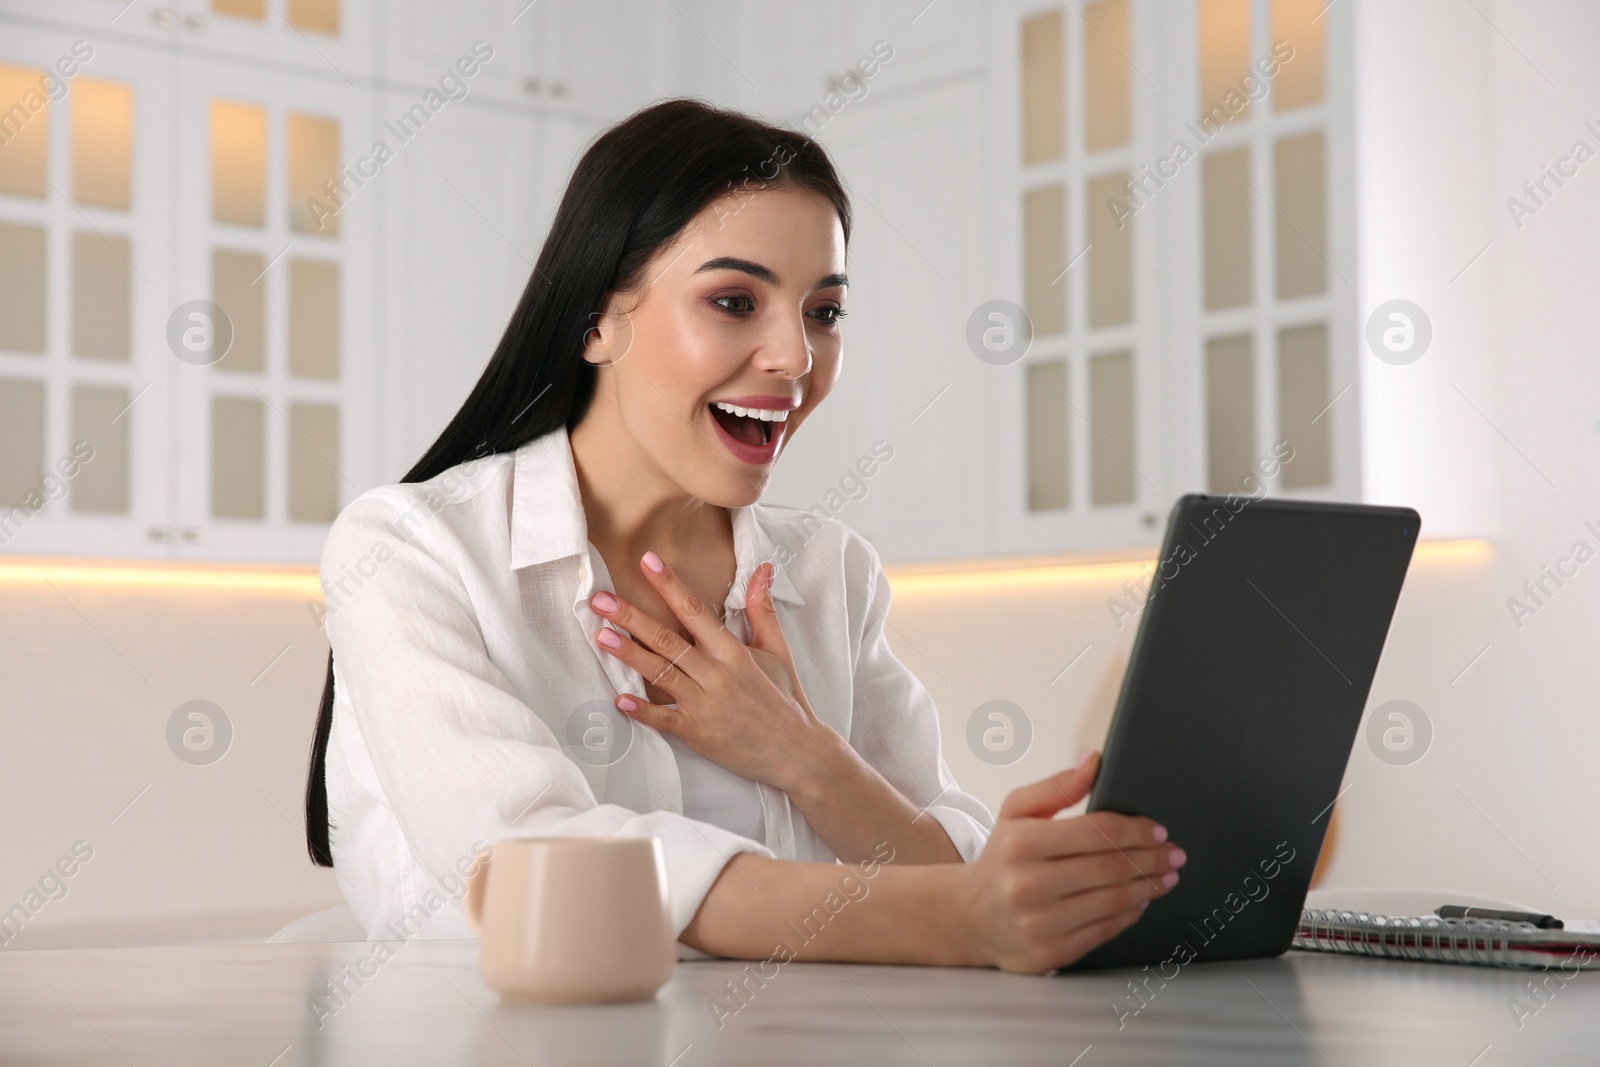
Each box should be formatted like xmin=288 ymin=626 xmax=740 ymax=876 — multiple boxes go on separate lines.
xmin=168 ymin=56 xmax=374 ymax=563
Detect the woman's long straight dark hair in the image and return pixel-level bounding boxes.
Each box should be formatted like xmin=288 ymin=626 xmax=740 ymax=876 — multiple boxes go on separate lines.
xmin=306 ymin=99 xmax=850 ymax=867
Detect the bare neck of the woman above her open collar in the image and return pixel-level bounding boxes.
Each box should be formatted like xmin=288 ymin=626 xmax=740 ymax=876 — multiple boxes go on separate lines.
xmin=568 ymin=411 xmax=731 ymax=575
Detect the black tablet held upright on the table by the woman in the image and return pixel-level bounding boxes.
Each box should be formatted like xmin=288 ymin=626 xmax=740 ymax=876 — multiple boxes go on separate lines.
xmin=1069 ymin=496 xmax=1419 ymax=977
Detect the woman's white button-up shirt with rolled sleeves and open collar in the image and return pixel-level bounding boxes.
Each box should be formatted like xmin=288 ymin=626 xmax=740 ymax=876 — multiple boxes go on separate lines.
xmin=322 ymin=430 xmax=994 ymax=939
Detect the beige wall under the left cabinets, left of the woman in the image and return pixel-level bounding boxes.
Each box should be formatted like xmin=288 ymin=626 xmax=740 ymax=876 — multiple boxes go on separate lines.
xmin=0 ymin=582 xmax=341 ymax=947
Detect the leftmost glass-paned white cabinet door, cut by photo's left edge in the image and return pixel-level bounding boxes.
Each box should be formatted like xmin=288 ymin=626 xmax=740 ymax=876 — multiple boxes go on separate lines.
xmin=0 ymin=26 xmax=173 ymax=555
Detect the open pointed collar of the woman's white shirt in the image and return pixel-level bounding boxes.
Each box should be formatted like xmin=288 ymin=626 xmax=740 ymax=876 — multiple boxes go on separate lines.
xmin=510 ymin=427 xmax=805 ymax=608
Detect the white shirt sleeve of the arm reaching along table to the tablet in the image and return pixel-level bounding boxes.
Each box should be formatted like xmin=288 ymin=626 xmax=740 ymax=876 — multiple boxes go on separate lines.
xmin=322 ymin=490 xmax=771 ymax=934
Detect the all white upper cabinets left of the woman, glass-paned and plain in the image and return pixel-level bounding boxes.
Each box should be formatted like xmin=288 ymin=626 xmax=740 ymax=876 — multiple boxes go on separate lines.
xmin=0 ymin=0 xmax=569 ymax=563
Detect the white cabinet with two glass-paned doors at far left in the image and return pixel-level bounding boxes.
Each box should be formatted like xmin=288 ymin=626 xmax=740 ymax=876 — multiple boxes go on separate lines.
xmin=0 ymin=5 xmax=376 ymax=561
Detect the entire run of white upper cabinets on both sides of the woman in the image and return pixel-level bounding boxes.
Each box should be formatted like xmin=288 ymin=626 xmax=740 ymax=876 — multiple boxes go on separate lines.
xmin=0 ymin=0 xmax=1363 ymax=561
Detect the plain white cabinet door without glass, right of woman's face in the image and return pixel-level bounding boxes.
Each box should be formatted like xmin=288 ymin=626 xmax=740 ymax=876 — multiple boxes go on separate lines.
xmin=800 ymin=82 xmax=997 ymax=561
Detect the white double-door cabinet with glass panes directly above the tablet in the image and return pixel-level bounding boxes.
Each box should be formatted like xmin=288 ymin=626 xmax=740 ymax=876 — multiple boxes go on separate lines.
xmin=992 ymin=0 xmax=1360 ymax=563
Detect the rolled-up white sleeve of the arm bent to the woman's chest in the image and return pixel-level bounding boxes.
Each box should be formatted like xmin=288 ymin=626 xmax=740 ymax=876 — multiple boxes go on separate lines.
xmin=846 ymin=537 xmax=995 ymax=862
